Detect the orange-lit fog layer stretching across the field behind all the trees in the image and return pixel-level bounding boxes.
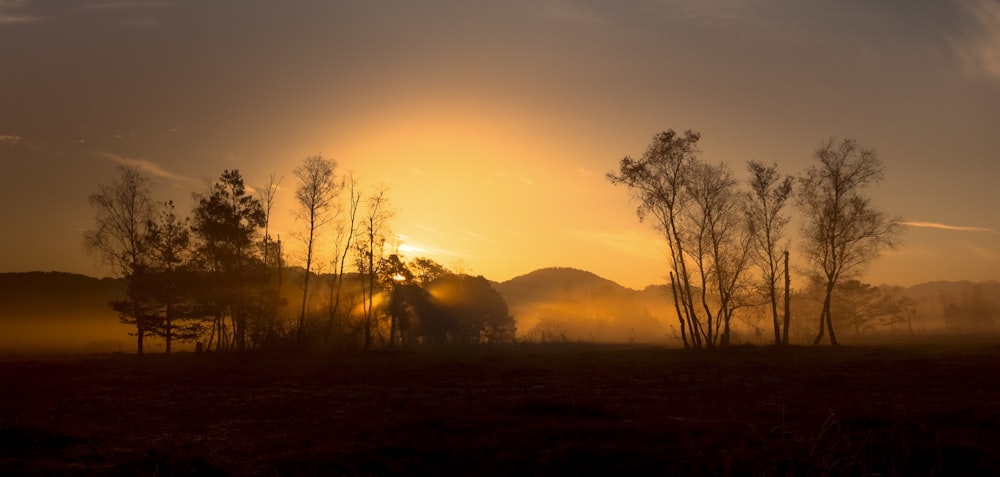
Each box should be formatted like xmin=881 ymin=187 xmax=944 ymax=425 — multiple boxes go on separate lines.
xmin=0 ymin=268 xmax=1000 ymax=354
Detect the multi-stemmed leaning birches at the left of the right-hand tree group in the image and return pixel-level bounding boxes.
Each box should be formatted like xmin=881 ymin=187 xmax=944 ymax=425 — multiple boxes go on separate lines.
xmin=607 ymin=130 xmax=750 ymax=348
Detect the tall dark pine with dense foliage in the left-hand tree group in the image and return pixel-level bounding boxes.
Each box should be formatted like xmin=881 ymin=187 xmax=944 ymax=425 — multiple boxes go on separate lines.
xmin=192 ymin=170 xmax=265 ymax=350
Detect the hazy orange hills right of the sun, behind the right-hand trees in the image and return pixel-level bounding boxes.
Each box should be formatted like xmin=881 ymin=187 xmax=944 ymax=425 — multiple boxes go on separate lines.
xmin=495 ymin=268 xmax=1000 ymax=343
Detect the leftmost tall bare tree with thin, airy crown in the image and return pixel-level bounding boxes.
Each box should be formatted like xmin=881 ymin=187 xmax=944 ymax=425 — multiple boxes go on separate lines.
xmin=84 ymin=166 xmax=153 ymax=354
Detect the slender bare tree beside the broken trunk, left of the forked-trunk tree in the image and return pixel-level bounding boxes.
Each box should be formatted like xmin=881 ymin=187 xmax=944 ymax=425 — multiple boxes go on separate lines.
xmin=746 ymin=161 xmax=793 ymax=345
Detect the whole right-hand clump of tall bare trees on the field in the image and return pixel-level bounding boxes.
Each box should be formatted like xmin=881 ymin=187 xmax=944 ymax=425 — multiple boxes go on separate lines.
xmin=607 ymin=130 xmax=900 ymax=348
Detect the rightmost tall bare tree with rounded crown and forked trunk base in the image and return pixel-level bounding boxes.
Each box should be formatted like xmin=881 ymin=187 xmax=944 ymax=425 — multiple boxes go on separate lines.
xmin=797 ymin=138 xmax=901 ymax=346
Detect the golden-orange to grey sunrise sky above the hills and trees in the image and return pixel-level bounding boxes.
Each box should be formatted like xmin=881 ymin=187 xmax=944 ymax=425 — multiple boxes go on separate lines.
xmin=0 ymin=0 xmax=1000 ymax=288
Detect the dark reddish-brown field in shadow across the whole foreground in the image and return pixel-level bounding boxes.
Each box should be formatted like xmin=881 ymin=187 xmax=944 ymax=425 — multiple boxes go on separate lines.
xmin=0 ymin=344 xmax=1000 ymax=476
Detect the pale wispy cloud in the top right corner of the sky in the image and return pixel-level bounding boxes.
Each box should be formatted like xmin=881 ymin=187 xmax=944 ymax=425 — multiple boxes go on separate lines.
xmin=950 ymin=0 xmax=1000 ymax=80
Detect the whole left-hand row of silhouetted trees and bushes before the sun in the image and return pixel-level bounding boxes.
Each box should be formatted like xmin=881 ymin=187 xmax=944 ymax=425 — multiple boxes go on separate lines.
xmin=85 ymin=156 xmax=515 ymax=354
